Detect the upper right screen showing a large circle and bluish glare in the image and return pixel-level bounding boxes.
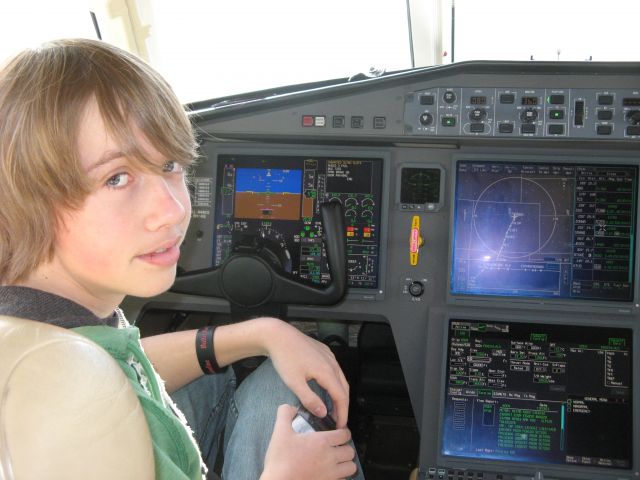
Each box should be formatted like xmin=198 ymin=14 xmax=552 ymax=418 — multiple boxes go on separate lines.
xmin=450 ymin=160 xmax=638 ymax=302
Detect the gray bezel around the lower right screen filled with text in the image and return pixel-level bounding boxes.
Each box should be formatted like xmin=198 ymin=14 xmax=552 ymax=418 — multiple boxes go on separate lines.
xmin=434 ymin=312 xmax=640 ymax=480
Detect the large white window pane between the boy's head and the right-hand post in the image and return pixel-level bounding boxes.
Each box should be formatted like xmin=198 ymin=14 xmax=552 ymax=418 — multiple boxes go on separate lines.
xmin=141 ymin=0 xmax=411 ymax=101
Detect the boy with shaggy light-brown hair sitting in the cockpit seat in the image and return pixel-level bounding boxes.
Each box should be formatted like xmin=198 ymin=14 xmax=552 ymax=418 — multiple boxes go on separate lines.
xmin=0 ymin=40 xmax=356 ymax=480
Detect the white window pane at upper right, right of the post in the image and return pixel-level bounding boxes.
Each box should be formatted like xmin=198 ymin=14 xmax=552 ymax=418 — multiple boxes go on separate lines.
xmin=450 ymin=0 xmax=640 ymax=62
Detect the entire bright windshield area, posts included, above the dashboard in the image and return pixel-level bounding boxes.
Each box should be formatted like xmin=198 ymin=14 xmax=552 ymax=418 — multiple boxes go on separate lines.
xmin=0 ymin=0 xmax=640 ymax=103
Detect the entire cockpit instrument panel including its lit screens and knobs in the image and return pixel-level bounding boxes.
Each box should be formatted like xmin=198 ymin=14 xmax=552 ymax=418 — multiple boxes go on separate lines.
xmin=128 ymin=62 xmax=640 ymax=480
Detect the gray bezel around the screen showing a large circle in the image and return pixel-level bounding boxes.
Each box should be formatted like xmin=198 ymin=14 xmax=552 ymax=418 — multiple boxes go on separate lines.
xmin=447 ymin=153 xmax=640 ymax=314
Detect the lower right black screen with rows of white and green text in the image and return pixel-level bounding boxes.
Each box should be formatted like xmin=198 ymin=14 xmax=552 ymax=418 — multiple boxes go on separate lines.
xmin=441 ymin=320 xmax=634 ymax=469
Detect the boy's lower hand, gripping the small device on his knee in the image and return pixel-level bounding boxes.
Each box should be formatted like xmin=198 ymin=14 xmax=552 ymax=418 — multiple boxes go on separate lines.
xmin=260 ymin=405 xmax=356 ymax=480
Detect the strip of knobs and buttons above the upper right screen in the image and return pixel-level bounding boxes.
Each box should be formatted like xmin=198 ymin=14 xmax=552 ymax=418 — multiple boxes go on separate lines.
xmin=404 ymin=87 xmax=640 ymax=140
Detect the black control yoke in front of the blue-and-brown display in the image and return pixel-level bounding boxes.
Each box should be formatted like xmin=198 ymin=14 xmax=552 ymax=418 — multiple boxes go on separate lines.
xmin=171 ymin=202 xmax=347 ymax=308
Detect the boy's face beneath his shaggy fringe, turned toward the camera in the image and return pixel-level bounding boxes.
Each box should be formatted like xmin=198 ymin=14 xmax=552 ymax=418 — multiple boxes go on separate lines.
xmin=34 ymin=101 xmax=191 ymax=314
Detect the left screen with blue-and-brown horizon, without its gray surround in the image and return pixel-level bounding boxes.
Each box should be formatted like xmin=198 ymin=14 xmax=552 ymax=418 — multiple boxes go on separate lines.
xmin=213 ymin=155 xmax=382 ymax=288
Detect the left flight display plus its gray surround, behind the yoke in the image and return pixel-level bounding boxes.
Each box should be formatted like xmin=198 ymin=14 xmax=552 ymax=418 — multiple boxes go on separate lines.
xmin=179 ymin=143 xmax=388 ymax=298
